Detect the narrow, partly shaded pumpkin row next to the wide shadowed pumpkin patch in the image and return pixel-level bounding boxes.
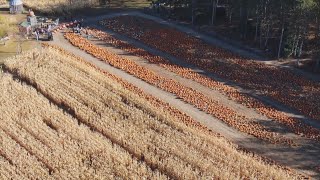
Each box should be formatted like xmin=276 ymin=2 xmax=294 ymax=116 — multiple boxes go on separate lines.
xmin=88 ymin=29 xmax=320 ymax=140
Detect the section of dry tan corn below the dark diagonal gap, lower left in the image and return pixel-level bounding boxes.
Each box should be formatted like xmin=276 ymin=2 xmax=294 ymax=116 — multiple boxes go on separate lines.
xmin=0 ymin=74 xmax=159 ymax=179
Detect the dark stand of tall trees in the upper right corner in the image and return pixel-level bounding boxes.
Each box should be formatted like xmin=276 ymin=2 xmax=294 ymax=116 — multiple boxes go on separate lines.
xmin=152 ymin=0 xmax=320 ymax=67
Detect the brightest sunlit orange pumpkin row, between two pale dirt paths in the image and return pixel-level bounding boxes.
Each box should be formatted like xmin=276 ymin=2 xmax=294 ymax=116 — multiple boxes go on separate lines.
xmin=65 ymin=33 xmax=293 ymax=145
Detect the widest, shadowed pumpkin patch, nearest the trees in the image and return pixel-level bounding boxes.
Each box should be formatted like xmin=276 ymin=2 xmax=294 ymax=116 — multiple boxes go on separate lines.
xmin=100 ymin=16 xmax=320 ymax=123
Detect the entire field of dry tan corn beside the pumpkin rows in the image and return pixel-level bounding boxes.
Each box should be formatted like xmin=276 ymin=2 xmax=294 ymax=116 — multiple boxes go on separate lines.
xmin=0 ymin=48 xmax=297 ymax=179
